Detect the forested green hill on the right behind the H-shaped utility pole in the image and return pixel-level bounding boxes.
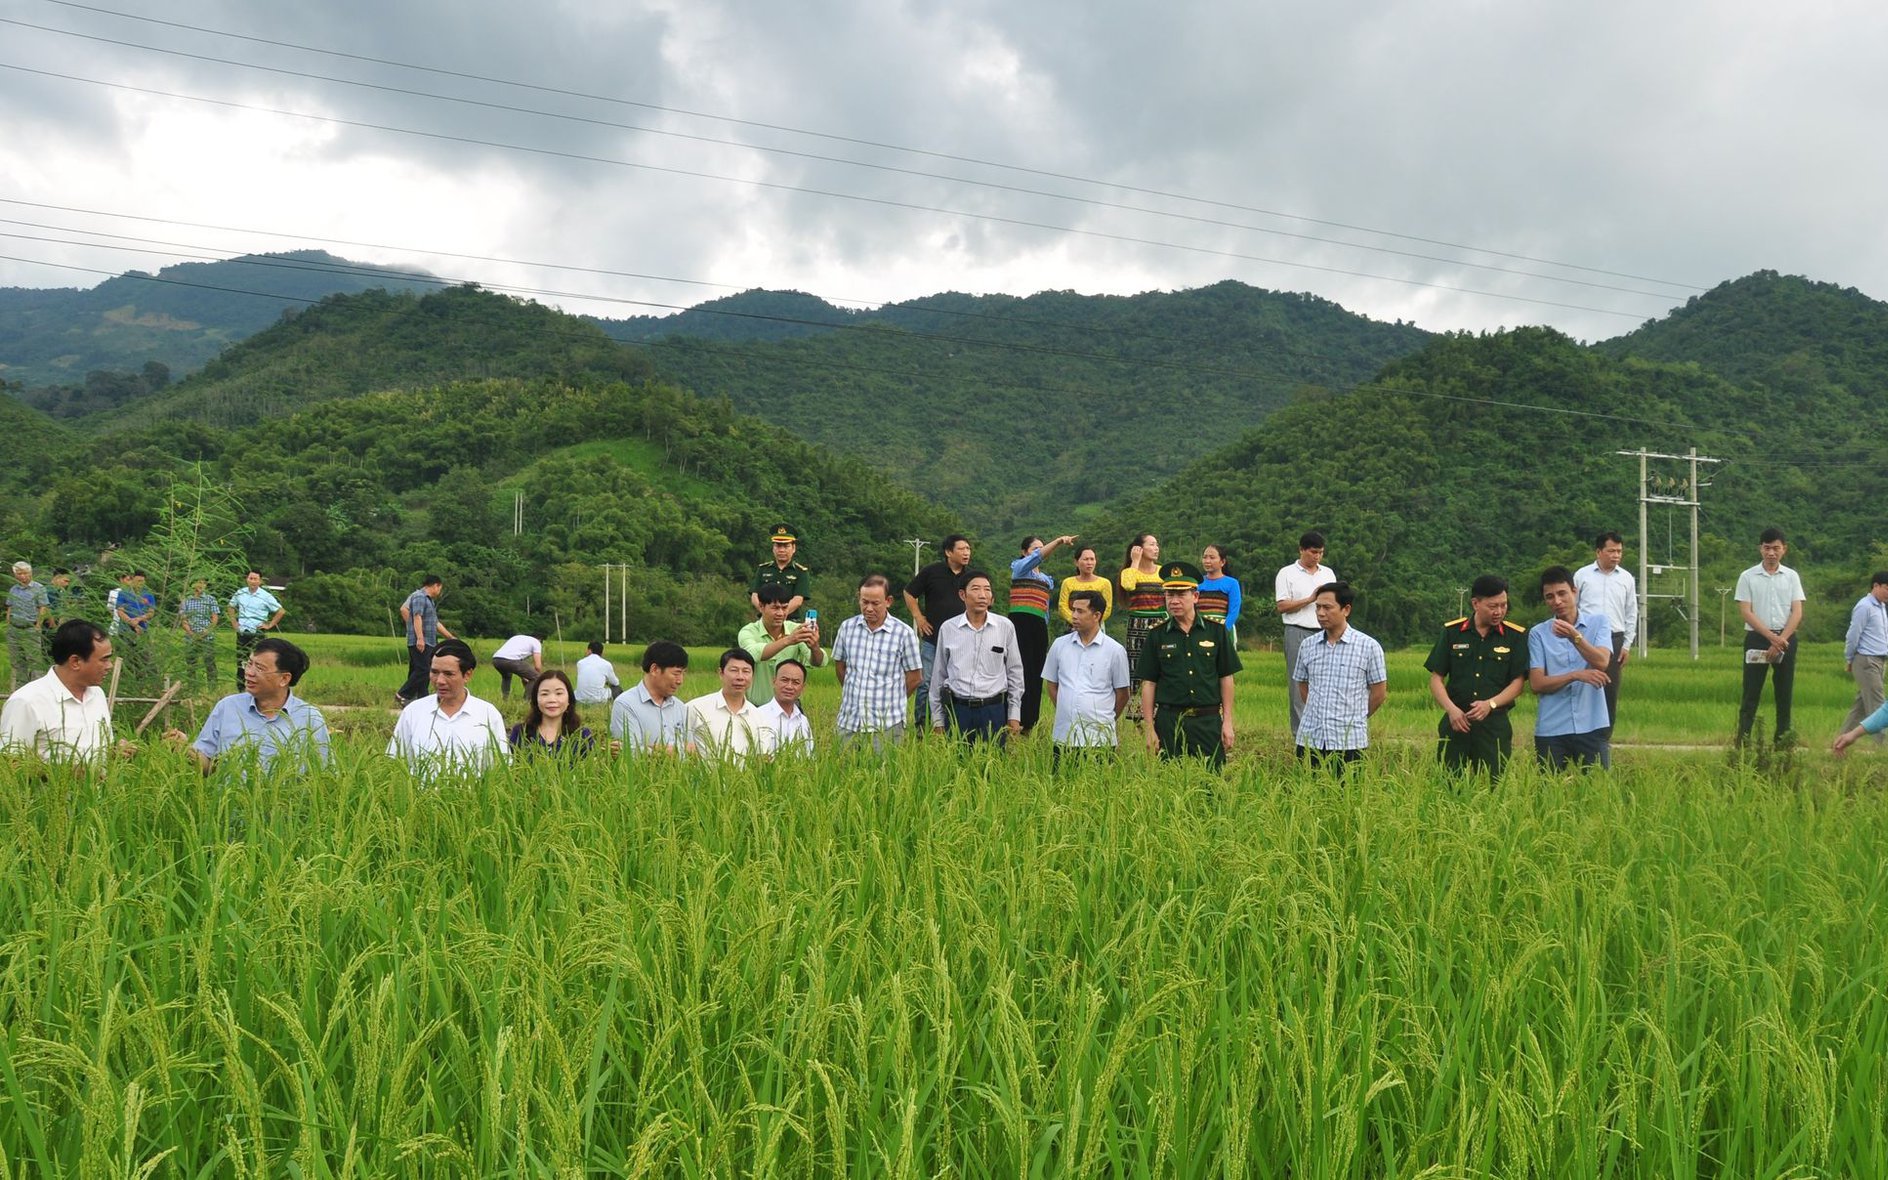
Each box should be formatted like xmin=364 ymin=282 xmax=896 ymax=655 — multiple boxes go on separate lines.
xmin=1104 ymin=329 xmax=1888 ymax=644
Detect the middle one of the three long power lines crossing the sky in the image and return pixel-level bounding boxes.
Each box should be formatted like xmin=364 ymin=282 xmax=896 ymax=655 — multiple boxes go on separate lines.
xmin=0 ymin=17 xmax=1697 ymax=298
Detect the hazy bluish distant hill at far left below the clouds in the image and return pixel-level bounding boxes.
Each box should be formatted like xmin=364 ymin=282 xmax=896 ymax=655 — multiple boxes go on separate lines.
xmin=0 ymin=249 xmax=438 ymax=389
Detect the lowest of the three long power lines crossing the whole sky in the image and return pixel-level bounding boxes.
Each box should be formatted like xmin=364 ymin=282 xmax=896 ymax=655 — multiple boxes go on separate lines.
xmin=0 ymin=62 xmax=1644 ymax=319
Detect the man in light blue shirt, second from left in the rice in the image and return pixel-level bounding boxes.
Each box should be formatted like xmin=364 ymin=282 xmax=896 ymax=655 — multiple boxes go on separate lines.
xmin=164 ymin=636 xmax=329 ymax=772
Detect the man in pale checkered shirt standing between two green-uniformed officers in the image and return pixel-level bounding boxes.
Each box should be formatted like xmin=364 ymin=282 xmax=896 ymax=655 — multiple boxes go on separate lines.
xmin=1291 ymin=582 xmax=1390 ymax=772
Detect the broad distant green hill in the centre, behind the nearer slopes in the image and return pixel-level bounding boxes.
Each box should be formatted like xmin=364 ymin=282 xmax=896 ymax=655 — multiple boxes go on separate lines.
xmin=612 ymin=281 xmax=1429 ymax=532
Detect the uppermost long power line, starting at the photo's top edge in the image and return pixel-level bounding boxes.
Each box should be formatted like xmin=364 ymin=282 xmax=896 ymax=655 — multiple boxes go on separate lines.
xmin=33 ymin=0 xmax=1707 ymax=291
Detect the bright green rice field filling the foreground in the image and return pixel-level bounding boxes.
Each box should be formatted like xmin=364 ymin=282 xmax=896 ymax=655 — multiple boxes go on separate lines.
xmin=0 ymin=636 xmax=1888 ymax=1178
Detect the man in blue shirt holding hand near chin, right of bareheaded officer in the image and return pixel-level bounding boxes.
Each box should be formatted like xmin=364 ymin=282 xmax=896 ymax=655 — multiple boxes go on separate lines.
xmin=1527 ymin=565 xmax=1612 ymax=770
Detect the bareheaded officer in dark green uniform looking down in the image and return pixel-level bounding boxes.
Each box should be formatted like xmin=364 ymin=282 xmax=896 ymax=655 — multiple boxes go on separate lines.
xmin=1424 ymin=574 xmax=1527 ymax=778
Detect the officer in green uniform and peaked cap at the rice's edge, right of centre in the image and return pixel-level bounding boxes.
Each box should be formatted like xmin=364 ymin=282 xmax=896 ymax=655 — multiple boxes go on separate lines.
xmin=1135 ymin=561 xmax=1240 ymax=770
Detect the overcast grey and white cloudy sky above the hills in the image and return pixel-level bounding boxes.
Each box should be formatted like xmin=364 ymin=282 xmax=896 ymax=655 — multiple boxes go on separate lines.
xmin=0 ymin=0 xmax=1888 ymax=340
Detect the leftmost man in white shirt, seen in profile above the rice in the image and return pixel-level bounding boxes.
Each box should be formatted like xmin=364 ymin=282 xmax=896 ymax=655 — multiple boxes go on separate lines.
xmin=0 ymin=619 xmax=118 ymax=763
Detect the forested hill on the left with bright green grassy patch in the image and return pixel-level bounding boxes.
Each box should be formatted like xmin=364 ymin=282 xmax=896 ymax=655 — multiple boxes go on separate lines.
xmin=0 ymin=289 xmax=955 ymax=642
